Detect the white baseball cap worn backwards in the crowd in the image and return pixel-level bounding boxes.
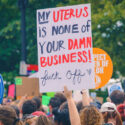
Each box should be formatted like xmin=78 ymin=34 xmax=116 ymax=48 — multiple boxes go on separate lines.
xmin=100 ymin=102 xmax=117 ymax=112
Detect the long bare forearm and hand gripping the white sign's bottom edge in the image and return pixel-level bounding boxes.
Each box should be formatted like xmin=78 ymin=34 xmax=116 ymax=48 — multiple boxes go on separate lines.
xmin=64 ymin=86 xmax=81 ymax=125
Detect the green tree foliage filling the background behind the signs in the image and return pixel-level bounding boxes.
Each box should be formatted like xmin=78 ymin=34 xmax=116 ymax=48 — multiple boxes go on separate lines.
xmin=0 ymin=0 xmax=125 ymax=81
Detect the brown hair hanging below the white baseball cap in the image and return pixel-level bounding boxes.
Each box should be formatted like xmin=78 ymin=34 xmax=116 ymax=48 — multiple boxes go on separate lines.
xmin=102 ymin=111 xmax=122 ymax=125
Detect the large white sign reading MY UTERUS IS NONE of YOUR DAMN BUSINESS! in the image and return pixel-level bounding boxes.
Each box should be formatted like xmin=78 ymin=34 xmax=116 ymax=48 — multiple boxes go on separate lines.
xmin=37 ymin=4 xmax=95 ymax=92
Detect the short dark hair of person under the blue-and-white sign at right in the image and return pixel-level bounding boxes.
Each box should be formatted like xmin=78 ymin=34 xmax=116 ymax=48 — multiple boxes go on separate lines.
xmin=110 ymin=90 xmax=124 ymax=105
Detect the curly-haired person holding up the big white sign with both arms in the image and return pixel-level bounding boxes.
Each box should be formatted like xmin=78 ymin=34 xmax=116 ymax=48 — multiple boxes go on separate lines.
xmin=64 ymin=86 xmax=103 ymax=125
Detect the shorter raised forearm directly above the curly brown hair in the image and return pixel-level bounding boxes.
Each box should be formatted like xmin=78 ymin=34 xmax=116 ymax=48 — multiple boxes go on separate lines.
xmin=82 ymin=89 xmax=90 ymax=106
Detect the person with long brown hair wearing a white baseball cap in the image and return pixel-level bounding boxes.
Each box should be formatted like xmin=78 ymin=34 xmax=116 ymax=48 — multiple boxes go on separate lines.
xmin=100 ymin=102 xmax=122 ymax=125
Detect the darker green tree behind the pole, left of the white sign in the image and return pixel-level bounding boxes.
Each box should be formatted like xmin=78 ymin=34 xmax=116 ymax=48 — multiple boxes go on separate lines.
xmin=0 ymin=0 xmax=66 ymax=82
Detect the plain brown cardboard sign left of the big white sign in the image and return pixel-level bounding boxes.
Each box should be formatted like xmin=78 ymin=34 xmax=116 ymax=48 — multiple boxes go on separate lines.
xmin=16 ymin=77 xmax=39 ymax=96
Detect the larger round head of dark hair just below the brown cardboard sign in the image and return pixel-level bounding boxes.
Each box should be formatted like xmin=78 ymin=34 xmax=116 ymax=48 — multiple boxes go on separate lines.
xmin=22 ymin=100 xmax=37 ymax=115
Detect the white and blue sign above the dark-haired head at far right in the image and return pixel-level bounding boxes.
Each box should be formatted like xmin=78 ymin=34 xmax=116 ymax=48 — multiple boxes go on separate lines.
xmin=108 ymin=83 xmax=123 ymax=95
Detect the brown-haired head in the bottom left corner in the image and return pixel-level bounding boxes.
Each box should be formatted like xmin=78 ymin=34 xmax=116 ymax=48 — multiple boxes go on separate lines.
xmin=0 ymin=106 xmax=22 ymax=125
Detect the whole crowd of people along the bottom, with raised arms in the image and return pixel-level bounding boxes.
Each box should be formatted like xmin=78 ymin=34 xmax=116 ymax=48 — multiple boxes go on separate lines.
xmin=0 ymin=86 xmax=125 ymax=125
